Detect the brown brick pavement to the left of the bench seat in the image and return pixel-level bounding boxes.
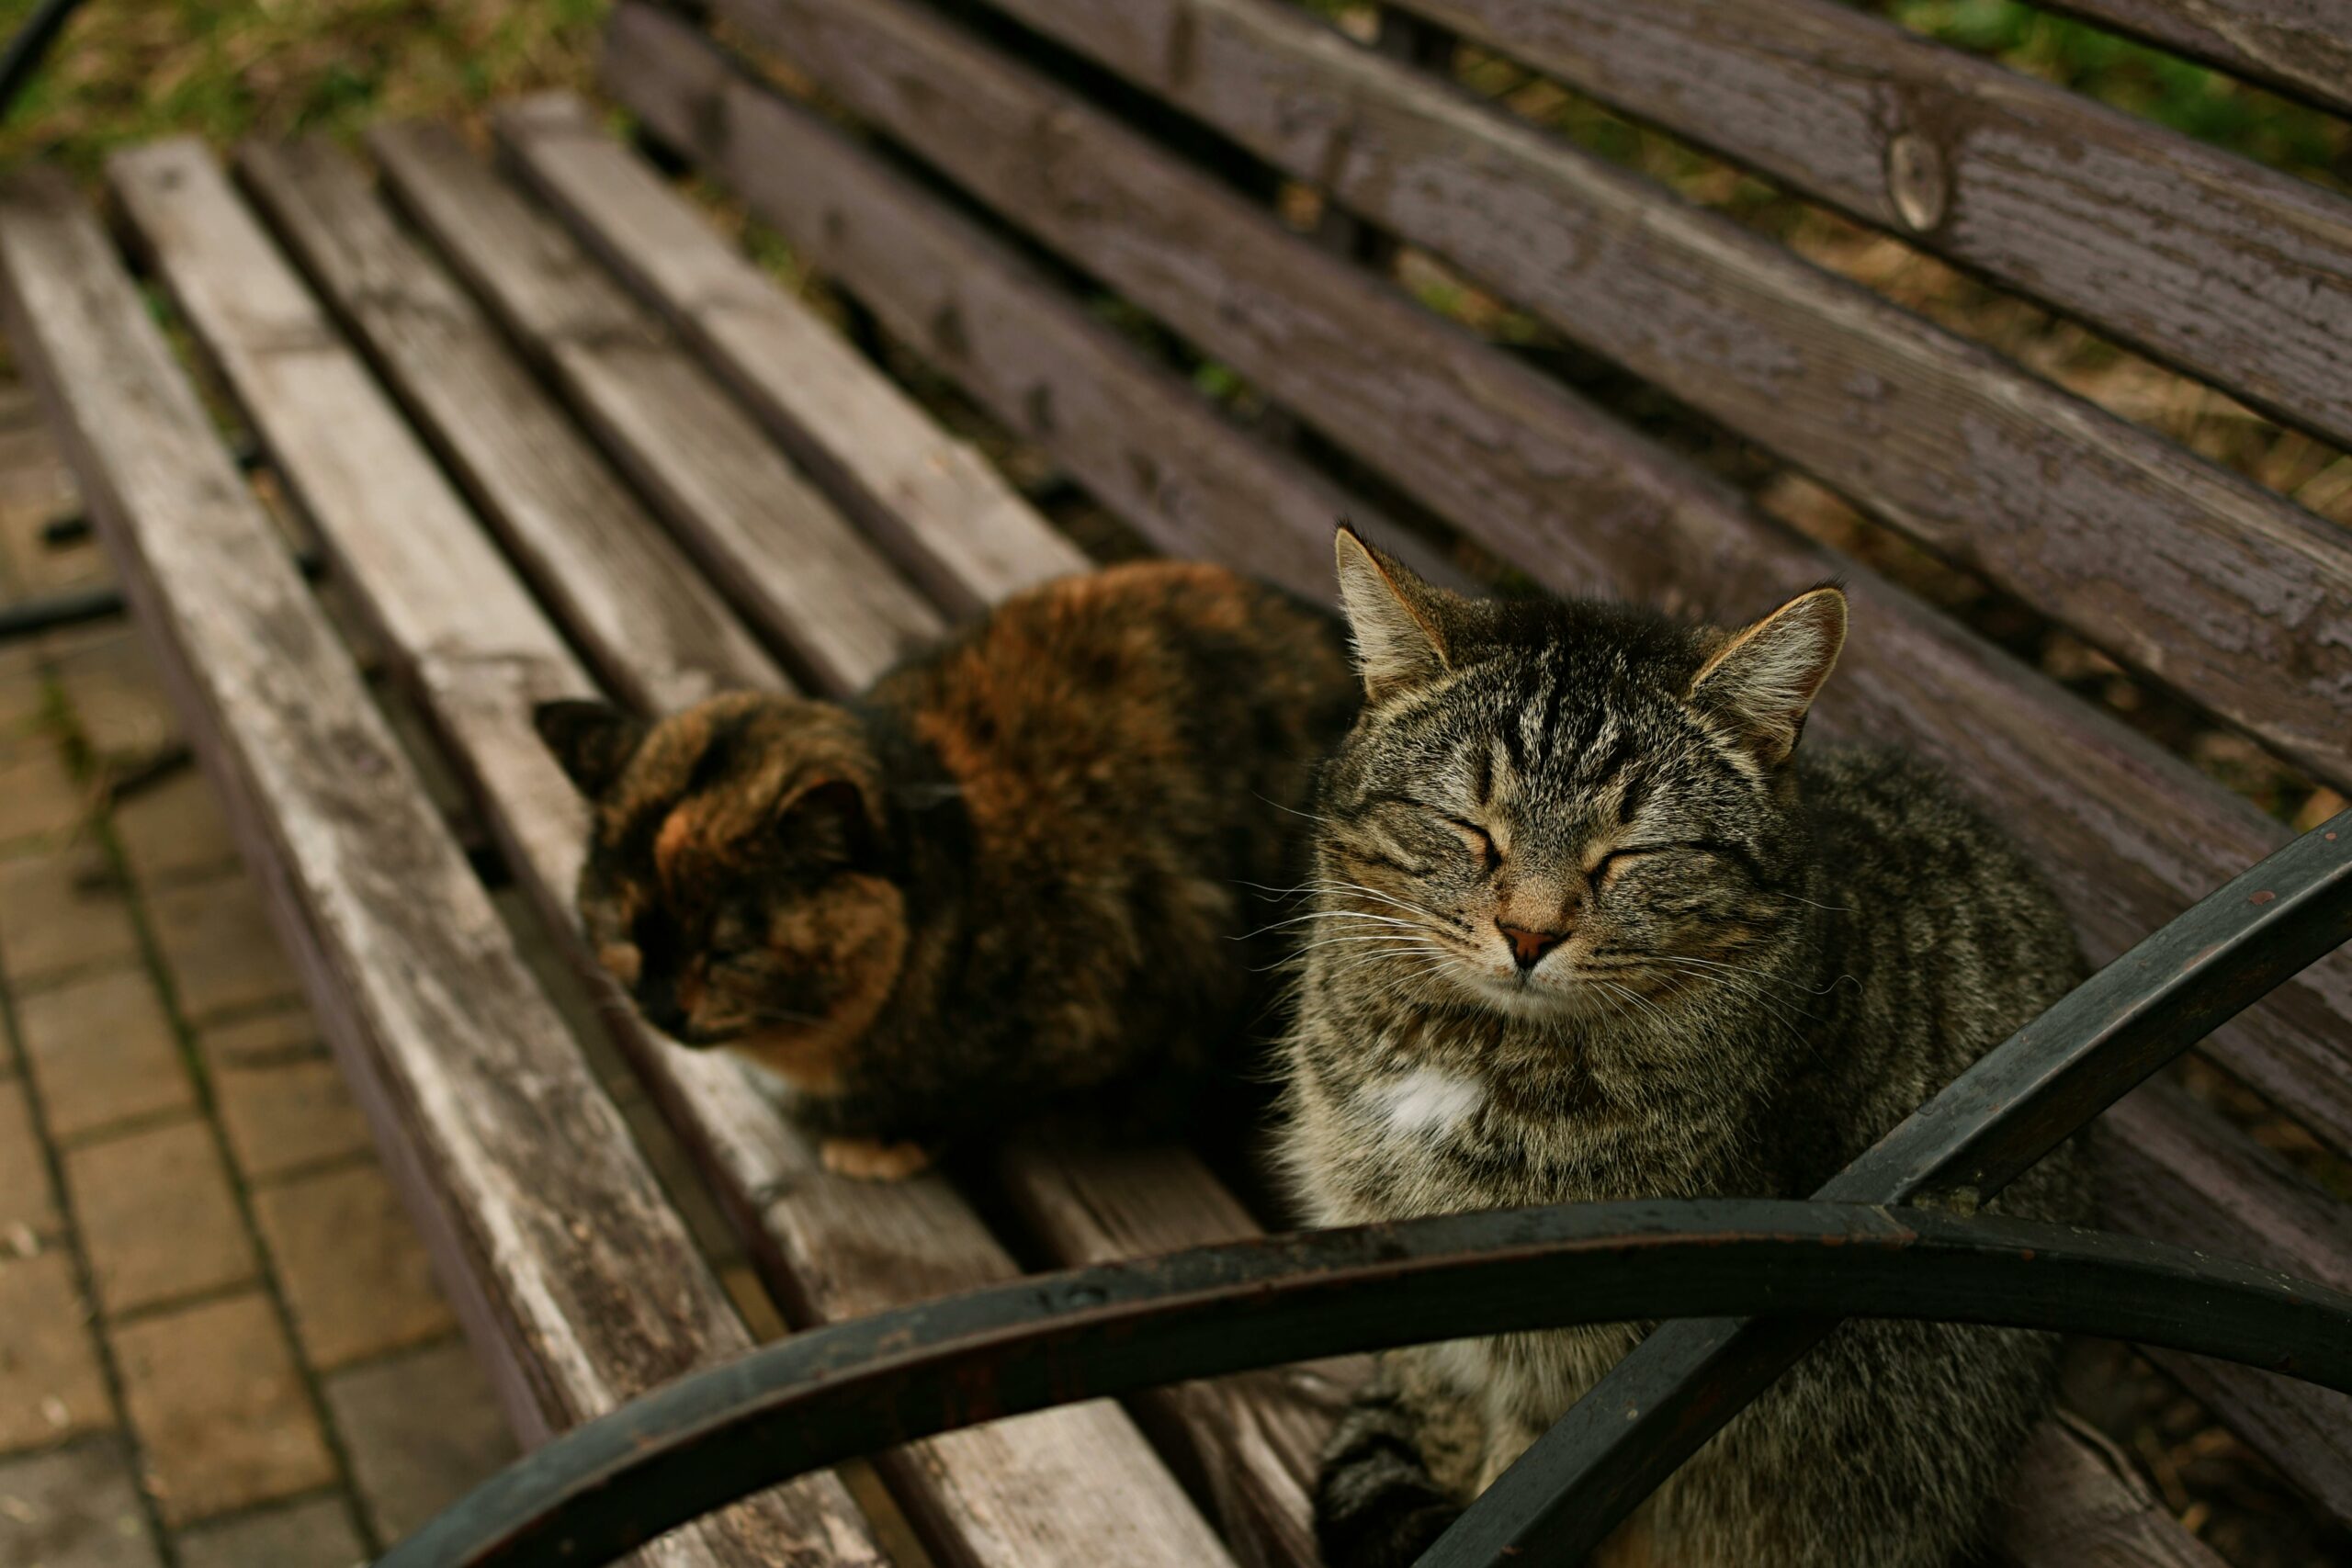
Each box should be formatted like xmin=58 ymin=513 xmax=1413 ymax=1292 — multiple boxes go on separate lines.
xmin=0 ymin=388 xmax=781 ymax=1568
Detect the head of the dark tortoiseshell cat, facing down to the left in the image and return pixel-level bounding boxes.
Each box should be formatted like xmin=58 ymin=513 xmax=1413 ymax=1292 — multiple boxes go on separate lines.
xmin=534 ymin=694 xmax=906 ymax=1090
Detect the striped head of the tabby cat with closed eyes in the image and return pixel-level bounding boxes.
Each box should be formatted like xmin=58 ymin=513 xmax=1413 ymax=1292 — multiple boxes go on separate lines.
xmin=1315 ymin=529 xmax=1847 ymax=1021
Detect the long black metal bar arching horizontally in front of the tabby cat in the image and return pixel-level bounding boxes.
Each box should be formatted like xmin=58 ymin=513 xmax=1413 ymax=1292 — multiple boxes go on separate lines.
xmin=379 ymin=1199 xmax=2352 ymax=1568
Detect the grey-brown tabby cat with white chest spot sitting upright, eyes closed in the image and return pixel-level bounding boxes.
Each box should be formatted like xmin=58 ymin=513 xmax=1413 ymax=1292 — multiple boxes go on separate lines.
xmin=1284 ymin=531 xmax=2088 ymax=1568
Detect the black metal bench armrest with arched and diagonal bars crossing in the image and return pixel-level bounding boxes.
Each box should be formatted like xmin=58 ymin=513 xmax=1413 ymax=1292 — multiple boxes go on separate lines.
xmin=379 ymin=811 xmax=2352 ymax=1568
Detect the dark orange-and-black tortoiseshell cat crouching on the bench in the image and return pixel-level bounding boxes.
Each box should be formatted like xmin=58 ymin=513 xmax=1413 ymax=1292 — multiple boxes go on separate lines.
xmin=537 ymin=562 xmax=1360 ymax=1178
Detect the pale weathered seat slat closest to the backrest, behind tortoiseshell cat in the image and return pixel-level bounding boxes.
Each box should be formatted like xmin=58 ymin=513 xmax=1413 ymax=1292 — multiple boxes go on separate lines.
xmin=494 ymin=94 xmax=1089 ymax=616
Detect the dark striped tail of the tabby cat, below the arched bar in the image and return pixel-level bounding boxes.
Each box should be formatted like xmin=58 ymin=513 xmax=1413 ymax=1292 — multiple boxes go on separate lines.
xmin=1315 ymin=1378 xmax=1461 ymax=1568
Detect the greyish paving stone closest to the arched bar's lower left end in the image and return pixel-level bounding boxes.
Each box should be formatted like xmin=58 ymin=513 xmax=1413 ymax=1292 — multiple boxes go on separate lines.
xmin=327 ymin=1340 xmax=515 ymax=1540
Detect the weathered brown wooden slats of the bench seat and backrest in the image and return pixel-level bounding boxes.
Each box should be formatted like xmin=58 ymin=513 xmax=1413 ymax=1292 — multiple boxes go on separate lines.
xmin=0 ymin=0 xmax=2352 ymax=1568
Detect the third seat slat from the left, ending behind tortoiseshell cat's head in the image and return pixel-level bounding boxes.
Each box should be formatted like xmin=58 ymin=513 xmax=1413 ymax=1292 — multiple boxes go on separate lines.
xmin=238 ymin=139 xmax=781 ymax=710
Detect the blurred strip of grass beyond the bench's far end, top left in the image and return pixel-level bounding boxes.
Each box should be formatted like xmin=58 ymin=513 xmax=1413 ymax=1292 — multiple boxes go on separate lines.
xmin=0 ymin=0 xmax=606 ymax=176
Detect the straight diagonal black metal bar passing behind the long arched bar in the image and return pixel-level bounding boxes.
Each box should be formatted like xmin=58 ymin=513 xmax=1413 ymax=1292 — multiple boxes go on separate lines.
xmin=1420 ymin=811 xmax=2352 ymax=1568
